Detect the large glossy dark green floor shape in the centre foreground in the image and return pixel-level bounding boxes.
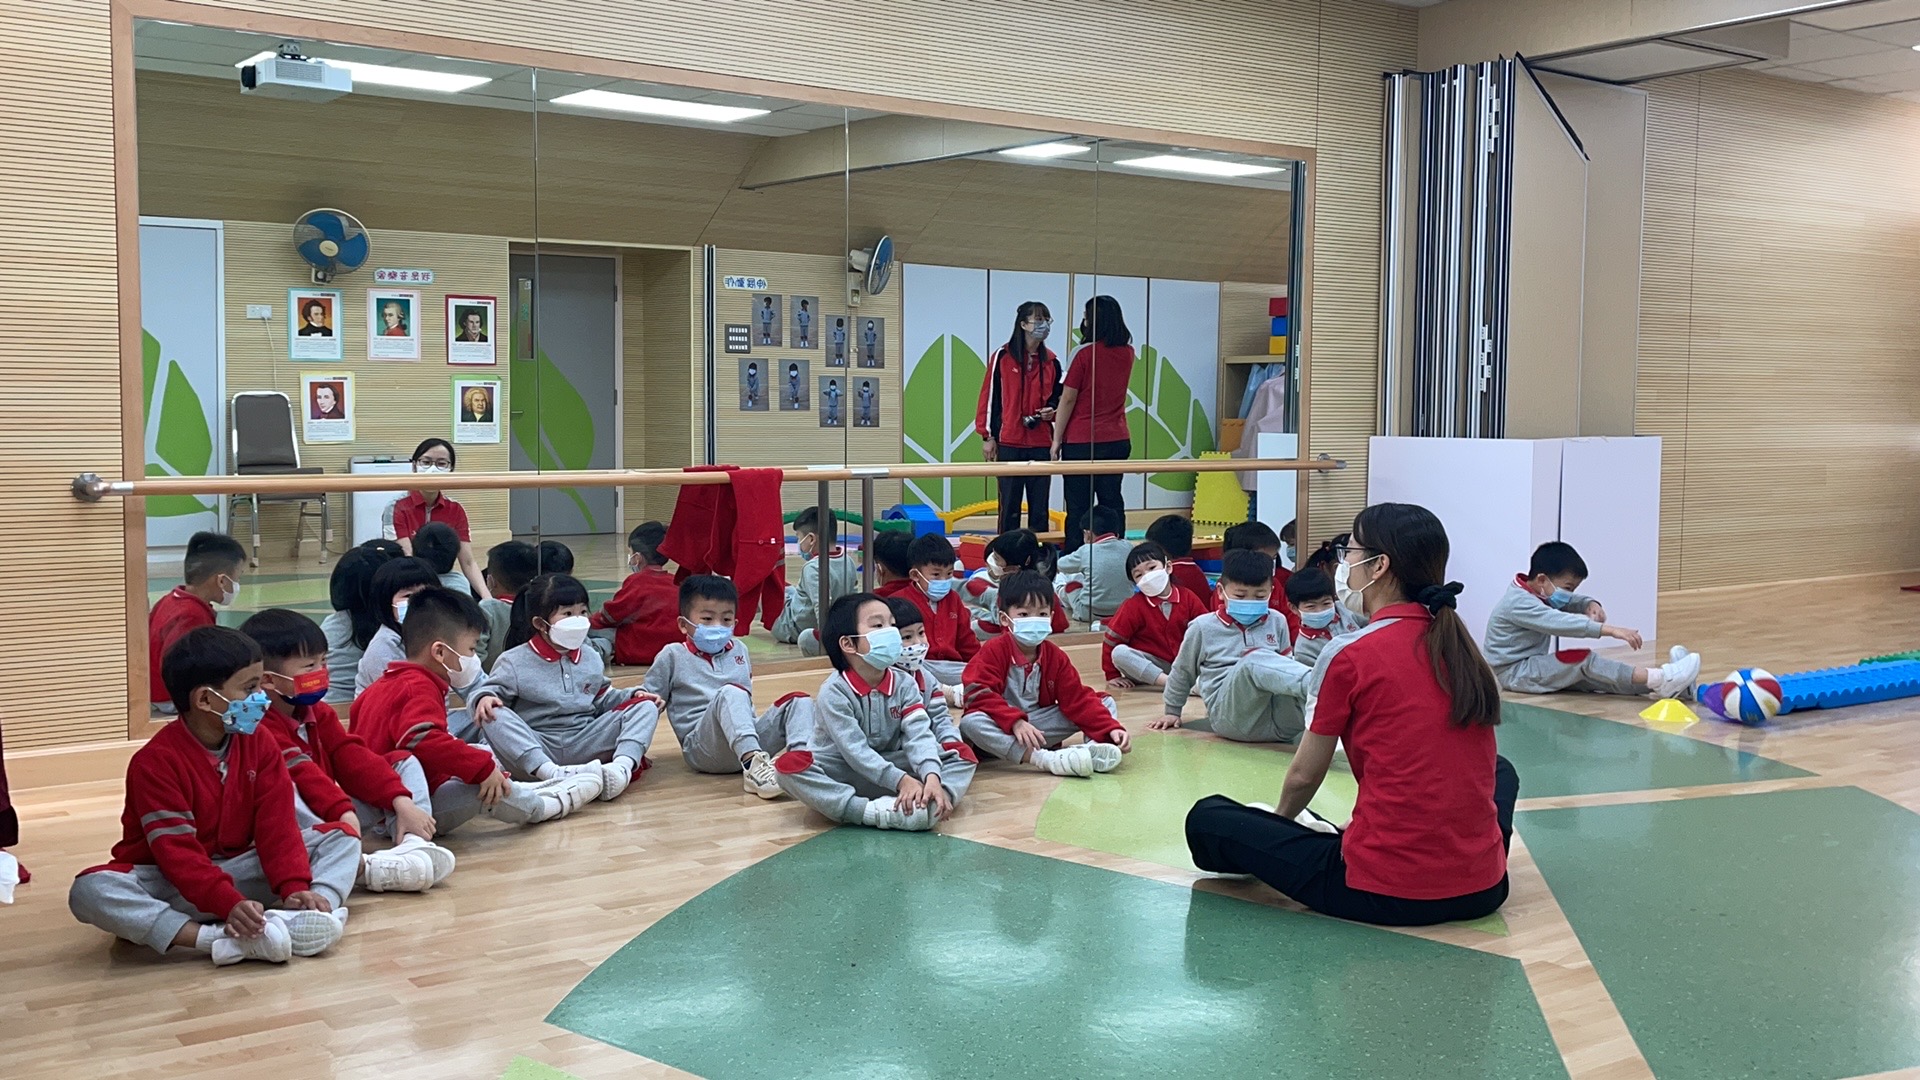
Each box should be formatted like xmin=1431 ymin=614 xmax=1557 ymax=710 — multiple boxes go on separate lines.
xmin=547 ymin=828 xmax=1567 ymax=1080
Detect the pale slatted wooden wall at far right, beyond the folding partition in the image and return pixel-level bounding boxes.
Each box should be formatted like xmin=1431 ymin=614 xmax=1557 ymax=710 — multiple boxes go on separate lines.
xmin=1636 ymin=71 xmax=1920 ymax=588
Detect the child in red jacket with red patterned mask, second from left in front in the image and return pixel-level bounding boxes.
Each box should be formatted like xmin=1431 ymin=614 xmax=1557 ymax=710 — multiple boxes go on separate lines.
xmin=240 ymin=607 xmax=453 ymax=892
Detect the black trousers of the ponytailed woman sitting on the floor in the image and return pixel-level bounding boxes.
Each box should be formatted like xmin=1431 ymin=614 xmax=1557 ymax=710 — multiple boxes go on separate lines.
xmin=1187 ymin=757 xmax=1521 ymax=926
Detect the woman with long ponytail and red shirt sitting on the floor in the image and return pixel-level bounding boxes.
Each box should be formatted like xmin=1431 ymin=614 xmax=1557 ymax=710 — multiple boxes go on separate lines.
xmin=1187 ymin=503 xmax=1521 ymax=926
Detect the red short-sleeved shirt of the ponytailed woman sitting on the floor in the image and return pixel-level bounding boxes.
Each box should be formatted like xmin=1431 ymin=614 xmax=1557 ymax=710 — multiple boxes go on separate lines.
xmin=1308 ymin=603 xmax=1507 ymax=899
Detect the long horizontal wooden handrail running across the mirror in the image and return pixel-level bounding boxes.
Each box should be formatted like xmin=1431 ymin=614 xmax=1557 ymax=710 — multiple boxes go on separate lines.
xmin=73 ymin=455 xmax=1346 ymax=502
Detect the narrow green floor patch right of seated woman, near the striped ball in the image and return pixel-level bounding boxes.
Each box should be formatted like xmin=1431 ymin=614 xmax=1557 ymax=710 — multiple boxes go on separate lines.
xmin=1496 ymin=701 xmax=1811 ymax=799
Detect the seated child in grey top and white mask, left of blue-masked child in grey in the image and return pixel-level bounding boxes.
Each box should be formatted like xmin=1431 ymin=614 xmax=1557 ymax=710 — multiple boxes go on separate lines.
xmin=470 ymin=575 xmax=660 ymax=799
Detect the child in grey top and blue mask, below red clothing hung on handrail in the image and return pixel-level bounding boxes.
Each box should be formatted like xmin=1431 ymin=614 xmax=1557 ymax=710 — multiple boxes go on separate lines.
xmin=641 ymin=575 xmax=812 ymax=799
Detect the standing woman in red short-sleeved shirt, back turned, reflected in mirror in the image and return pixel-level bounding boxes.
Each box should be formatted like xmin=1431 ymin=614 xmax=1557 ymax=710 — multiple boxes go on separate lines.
xmin=1054 ymin=296 xmax=1133 ymax=552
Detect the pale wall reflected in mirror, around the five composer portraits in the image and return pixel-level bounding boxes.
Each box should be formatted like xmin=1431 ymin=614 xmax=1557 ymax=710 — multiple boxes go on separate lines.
xmin=223 ymin=221 xmax=513 ymax=557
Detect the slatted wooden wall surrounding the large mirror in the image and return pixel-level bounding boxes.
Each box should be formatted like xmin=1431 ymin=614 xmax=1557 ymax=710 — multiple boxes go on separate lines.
xmin=0 ymin=0 xmax=1415 ymax=748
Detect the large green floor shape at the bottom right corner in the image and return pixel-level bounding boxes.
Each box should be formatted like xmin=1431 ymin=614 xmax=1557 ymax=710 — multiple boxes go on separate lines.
xmin=1519 ymin=774 xmax=1920 ymax=1080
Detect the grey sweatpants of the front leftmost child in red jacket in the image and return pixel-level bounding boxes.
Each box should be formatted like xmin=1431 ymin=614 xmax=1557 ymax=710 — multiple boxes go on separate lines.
xmin=67 ymin=828 xmax=361 ymax=953
